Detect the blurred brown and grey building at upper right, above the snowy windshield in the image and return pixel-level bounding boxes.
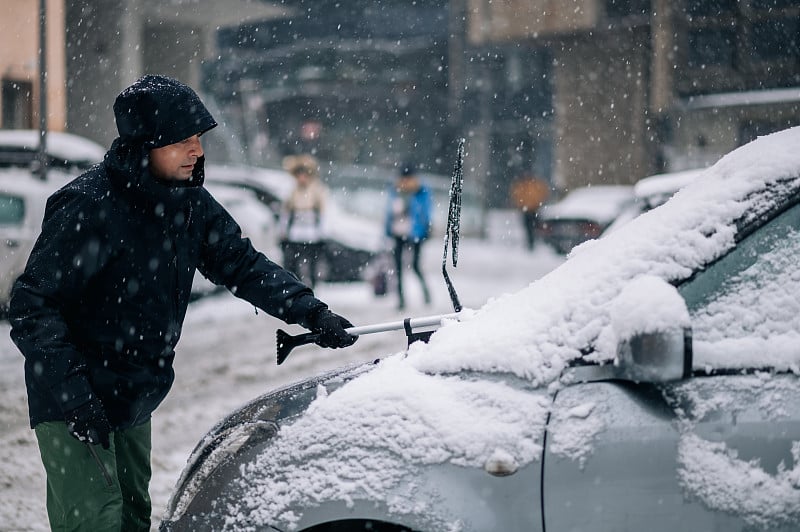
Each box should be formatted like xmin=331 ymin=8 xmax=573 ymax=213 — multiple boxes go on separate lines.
xmin=466 ymin=0 xmax=800 ymax=196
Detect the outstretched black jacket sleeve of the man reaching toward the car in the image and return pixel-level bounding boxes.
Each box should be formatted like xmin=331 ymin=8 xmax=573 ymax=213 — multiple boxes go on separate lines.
xmin=198 ymin=194 xmax=327 ymax=328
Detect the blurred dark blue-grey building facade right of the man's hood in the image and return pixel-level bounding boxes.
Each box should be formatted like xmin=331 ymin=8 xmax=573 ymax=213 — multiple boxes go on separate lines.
xmin=206 ymin=0 xmax=452 ymax=169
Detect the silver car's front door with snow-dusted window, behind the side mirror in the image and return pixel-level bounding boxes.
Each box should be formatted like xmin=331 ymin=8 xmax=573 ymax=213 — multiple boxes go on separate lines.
xmin=542 ymin=198 xmax=800 ymax=532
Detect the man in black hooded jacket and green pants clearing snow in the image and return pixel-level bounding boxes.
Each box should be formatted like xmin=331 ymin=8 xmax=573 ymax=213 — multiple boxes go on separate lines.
xmin=9 ymin=76 xmax=356 ymax=531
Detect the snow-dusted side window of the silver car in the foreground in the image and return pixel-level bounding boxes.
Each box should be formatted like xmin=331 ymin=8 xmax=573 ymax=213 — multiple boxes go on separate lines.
xmin=678 ymin=205 xmax=800 ymax=369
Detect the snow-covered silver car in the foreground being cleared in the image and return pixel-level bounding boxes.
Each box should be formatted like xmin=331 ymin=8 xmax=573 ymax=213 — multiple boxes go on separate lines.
xmin=160 ymin=127 xmax=800 ymax=532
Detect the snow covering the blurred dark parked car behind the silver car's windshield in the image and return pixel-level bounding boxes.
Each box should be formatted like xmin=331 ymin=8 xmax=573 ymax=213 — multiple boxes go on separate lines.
xmin=540 ymin=185 xmax=633 ymax=224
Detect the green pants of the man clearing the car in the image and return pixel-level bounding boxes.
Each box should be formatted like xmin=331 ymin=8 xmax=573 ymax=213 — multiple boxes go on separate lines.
xmin=34 ymin=421 xmax=151 ymax=532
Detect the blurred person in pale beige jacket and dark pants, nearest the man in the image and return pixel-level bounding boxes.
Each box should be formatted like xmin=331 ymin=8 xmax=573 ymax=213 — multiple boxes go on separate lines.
xmin=280 ymin=154 xmax=328 ymax=288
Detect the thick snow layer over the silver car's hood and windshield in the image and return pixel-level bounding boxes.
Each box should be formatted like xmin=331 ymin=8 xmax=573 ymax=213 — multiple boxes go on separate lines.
xmin=228 ymin=124 xmax=800 ymax=530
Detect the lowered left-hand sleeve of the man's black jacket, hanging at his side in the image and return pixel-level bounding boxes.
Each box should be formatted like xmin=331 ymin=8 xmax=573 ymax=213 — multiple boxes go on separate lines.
xmin=9 ymin=191 xmax=108 ymax=411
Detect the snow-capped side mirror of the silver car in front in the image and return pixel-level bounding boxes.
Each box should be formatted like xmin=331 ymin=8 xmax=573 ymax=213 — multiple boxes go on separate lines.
xmin=611 ymin=276 xmax=692 ymax=382
